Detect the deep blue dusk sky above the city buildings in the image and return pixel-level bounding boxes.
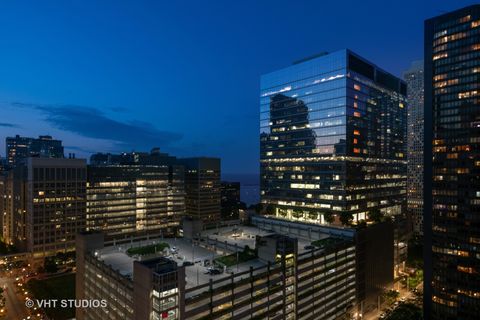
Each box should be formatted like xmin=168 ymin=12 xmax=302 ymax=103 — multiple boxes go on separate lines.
xmin=0 ymin=0 xmax=475 ymax=173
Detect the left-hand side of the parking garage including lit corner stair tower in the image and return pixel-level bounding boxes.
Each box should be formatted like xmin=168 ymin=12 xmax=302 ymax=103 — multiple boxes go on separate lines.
xmin=75 ymin=233 xmax=185 ymax=320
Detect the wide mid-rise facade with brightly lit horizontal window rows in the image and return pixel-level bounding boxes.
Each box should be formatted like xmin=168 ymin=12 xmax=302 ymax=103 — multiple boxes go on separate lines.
xmin=86 ymin=164 xmax=185 ymax=240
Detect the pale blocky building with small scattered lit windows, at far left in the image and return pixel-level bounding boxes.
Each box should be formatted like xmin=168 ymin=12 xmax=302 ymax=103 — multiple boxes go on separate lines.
xmin=6 ymin=158 xmax=86 ymax=258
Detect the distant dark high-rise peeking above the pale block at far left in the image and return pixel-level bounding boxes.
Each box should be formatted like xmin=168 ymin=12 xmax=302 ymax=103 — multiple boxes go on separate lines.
xmin=5 ymin=135 xmax=63 ymax=166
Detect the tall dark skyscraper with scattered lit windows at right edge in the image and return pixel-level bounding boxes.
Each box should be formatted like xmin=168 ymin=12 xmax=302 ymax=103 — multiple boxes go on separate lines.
xmin=424 ymin=5 xmax=480 ymax=320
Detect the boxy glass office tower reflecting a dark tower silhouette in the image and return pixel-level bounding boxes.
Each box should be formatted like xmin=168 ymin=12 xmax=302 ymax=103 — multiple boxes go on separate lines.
xmin=260 ymin=50 xmax=406 ymax=223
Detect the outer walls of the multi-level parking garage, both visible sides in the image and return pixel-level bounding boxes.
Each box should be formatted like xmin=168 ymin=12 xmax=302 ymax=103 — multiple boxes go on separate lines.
xmin=76 ymin=222 xmax=356 ymax=320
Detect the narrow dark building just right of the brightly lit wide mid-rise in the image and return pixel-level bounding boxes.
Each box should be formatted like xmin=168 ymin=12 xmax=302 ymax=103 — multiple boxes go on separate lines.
xmin=178 ymin=157 xmax=221 ymax=223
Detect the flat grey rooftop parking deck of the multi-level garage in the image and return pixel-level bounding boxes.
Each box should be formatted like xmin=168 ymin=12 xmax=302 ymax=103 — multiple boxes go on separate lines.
xmin=95 ymin=226 xmax=344 ymax=289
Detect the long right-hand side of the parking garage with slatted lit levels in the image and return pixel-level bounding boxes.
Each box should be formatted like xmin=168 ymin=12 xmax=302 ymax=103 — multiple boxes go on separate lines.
xmin=181 ymin=235 xmax=356 ymax=320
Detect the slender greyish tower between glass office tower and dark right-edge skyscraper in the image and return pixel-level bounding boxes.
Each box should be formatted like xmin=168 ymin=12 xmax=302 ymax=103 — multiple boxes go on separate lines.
xmin=403 ymin=61 xmax=424 ymax=236
